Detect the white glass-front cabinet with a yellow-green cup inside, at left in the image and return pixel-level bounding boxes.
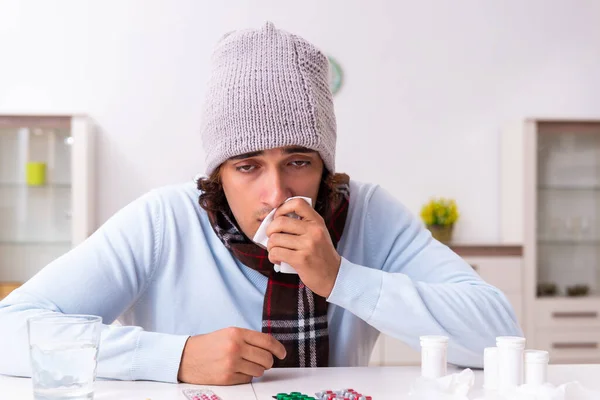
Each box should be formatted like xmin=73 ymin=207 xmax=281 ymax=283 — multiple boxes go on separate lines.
xmin=0 ymin=115 xmax=95 ymax=296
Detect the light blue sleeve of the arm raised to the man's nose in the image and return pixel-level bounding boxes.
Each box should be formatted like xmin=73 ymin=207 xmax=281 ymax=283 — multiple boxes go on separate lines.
xmin=327 ymin=188 xmax=523 ymax=367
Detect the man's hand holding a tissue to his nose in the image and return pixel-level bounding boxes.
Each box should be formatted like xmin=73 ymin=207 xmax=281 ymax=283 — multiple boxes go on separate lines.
xmin=267 ymin=199 xmax=342 ymax=298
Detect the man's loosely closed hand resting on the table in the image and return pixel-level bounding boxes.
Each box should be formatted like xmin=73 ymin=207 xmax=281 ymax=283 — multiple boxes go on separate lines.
xmin=177 ymin=328 xmax=286 ymax=385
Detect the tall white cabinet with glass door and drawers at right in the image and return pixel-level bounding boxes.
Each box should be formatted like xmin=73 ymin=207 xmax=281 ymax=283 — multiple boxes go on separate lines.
xmin=500 ymin=119 xmax=600 ymax=363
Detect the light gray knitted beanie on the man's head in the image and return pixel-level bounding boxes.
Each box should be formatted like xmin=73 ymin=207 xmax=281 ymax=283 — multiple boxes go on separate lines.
xmin=201 ymin=22 xmax=336 ymax=175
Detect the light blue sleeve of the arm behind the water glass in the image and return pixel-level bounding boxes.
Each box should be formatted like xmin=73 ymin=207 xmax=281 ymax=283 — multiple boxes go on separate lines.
xmin=0 ymin=192 xmax=188 ymax=382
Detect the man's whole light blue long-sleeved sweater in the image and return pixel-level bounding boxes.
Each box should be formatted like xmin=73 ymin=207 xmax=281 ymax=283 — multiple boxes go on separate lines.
xmin=0 ymin=181 xmax=522 ymax=382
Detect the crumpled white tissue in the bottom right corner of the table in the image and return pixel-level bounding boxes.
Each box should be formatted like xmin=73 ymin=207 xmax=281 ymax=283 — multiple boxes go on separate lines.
xmin=477 ymin=382 xmax=600 ymax=400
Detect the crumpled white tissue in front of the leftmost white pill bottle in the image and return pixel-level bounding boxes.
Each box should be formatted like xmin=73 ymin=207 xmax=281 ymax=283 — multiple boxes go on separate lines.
xmin=408 ymin=368 xmax=475 ymax=400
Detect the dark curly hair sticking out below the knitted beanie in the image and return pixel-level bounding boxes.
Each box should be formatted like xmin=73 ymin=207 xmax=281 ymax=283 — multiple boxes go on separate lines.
xmin=197 ymin=168 xmax=348 ymax=217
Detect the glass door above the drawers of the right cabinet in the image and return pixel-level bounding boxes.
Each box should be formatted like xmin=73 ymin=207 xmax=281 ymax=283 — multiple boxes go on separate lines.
xmin=531 ymin=121 xmax=600 ymax=296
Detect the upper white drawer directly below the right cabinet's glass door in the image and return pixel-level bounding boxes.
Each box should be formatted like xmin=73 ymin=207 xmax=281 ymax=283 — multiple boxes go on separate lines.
xmin=535 ymin=298 xmax=600 ymax=330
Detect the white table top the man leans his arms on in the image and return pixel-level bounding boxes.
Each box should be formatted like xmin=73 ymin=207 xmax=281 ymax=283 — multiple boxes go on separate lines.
xmin=0 ymin=364 xmax=600 ymax=400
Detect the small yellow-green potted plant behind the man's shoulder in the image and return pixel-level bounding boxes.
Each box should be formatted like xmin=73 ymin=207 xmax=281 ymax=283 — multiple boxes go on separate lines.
xmin=421 ymin=197 xmax=459 ymax=243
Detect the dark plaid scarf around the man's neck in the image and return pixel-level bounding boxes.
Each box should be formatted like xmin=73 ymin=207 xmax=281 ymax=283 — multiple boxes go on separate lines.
xmin=208 ymin=176 xmax=350 ymax=367
